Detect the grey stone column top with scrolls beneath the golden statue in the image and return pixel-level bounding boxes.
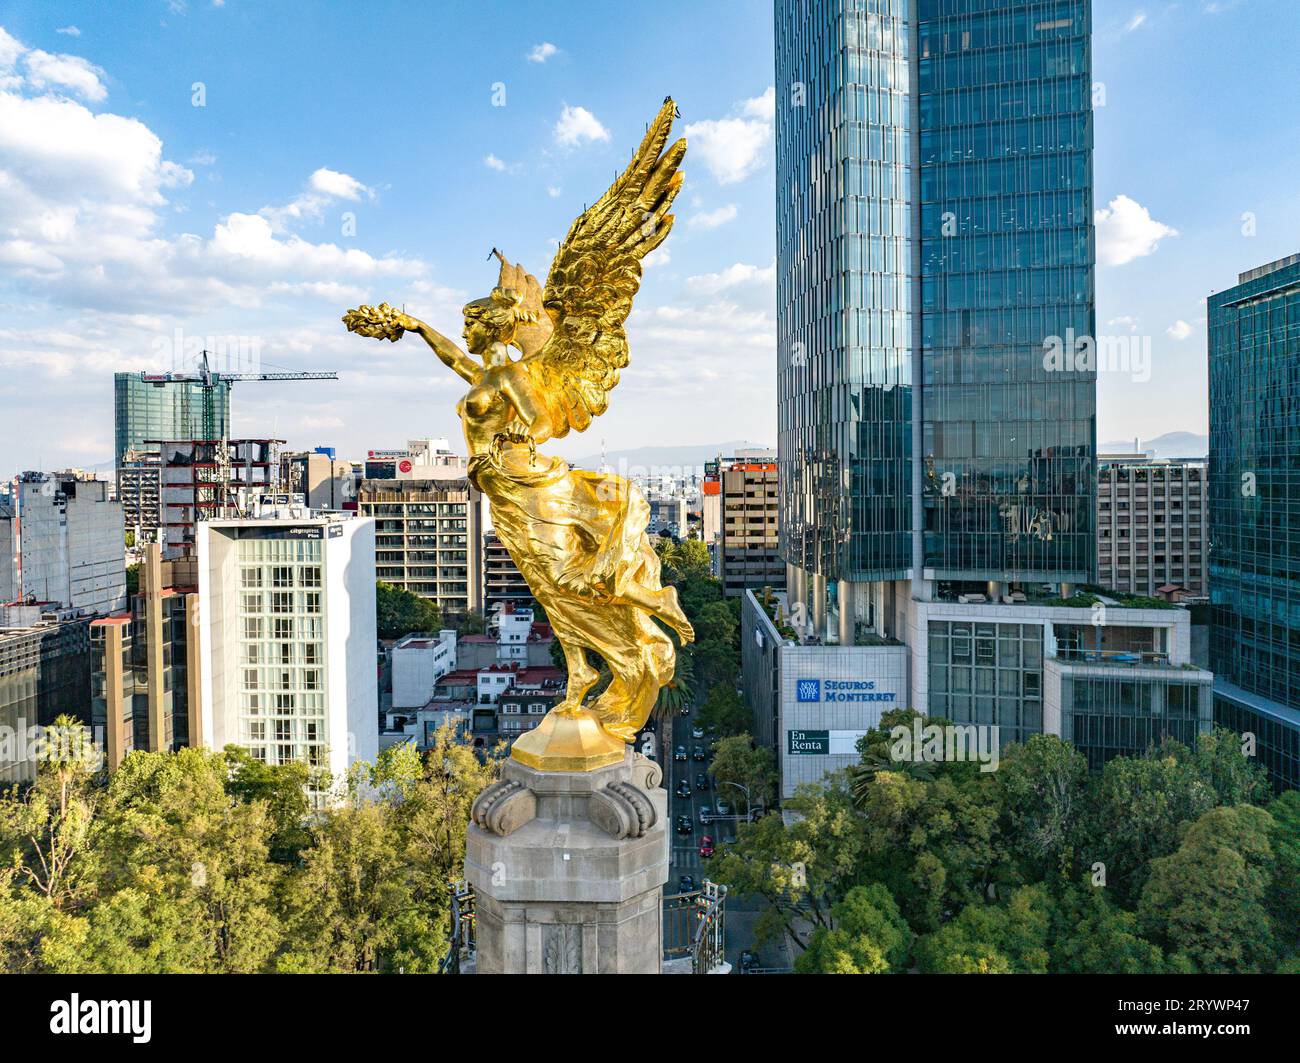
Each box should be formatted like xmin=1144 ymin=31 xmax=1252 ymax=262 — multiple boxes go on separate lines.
xmin=465 ymin=749 xmax=668 ymax=975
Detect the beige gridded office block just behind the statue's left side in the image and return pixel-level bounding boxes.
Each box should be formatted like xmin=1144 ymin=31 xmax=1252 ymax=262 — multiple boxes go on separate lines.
xmin=358 ymin=473 xmax=488 ymax=617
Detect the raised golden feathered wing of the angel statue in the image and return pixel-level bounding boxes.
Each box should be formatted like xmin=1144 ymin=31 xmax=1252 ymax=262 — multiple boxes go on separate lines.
xmin=524 ymin=97 xmax=686 ymax=437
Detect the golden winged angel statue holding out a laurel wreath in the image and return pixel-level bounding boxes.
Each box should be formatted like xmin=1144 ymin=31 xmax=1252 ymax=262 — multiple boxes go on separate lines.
xmin=343 ymin=99 xmax=694 ymax=771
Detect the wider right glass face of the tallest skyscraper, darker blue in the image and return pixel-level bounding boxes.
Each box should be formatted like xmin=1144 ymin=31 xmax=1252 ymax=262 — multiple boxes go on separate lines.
xmin=917 ymin=0 xmax=1096 ymax=582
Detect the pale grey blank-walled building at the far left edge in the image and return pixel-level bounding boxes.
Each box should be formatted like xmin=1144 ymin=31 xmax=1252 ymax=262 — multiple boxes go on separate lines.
xmin=0 ymin=472 xmax=126 ymax=615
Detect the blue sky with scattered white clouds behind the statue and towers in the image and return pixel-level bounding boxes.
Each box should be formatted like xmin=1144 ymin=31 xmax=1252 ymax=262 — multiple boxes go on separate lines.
xmin=0 ymin=0 xmax=1300 ymax=473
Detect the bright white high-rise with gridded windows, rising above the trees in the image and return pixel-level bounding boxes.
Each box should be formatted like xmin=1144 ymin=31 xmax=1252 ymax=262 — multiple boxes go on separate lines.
xmin=195 ymin=506 xmax=378 ymax=781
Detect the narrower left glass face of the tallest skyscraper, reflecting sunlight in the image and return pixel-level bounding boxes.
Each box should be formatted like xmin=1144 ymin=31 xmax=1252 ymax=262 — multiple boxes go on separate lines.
xmin=776 ymin=0 xmax=914 ymax=580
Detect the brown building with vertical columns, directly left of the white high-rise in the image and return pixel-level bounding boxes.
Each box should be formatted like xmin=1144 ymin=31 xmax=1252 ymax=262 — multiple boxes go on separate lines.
xmin=90 ymin=543 xmax=203 ymax=771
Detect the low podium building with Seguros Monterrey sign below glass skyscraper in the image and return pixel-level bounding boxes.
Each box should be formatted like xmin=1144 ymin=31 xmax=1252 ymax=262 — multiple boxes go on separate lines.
xmin=741 ymin=591 xmax=1214 ymax=797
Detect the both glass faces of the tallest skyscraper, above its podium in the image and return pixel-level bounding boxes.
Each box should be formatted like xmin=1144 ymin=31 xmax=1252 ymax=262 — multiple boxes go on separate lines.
xmin=776 ymin=0 xmax=1096 ymax=582
